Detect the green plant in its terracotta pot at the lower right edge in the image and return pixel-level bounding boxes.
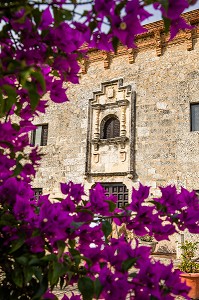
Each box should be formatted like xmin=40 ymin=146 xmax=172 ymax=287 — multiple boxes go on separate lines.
xmin=178 ymin=241 xmax=199 ymax=299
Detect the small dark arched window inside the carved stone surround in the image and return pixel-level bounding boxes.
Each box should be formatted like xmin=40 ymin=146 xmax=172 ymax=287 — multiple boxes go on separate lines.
xmin=101 ymin=116 xmax=120 ymax=139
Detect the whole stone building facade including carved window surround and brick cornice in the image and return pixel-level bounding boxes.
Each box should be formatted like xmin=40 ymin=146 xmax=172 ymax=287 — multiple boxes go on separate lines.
xmin=31 ymin=10 xmax=199 ymax=251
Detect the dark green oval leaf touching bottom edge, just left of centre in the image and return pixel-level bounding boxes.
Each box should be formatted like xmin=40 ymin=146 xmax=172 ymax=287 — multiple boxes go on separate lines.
xmin=78 ymin=277 xmax=94 ymax=300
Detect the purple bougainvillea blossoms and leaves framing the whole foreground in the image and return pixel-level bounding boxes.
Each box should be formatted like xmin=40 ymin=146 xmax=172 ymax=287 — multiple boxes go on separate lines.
xmin=0 ymin=0 xmax=199 ymax=300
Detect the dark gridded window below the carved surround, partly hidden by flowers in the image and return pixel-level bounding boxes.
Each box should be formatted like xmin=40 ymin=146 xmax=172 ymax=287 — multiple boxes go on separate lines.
xmin=101 ymin=183 xmax=128 ymax=208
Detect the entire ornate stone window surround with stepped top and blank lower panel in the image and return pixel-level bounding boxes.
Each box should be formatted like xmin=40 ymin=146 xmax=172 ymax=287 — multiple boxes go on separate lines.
xmin=86 ymin=78 xmax=135 ymax=176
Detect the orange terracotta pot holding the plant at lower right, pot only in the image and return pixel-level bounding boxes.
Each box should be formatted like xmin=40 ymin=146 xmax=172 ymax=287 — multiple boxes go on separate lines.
xmin=180 ymin=273 xmax=199 ymax=299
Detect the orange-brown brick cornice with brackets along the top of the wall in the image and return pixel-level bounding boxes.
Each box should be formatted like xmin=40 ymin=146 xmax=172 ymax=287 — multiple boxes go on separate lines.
xmin=83 ymin=9 xmax=199 ymax=69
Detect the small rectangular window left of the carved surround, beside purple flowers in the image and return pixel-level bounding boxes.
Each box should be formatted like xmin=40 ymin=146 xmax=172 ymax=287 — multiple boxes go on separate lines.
xmin=31 ymin=124 xmax=48 ymax=146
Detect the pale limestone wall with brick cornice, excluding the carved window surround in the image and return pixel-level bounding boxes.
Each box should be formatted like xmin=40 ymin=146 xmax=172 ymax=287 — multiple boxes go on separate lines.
xmin=34 ymin=11 xmax=199 ymax=253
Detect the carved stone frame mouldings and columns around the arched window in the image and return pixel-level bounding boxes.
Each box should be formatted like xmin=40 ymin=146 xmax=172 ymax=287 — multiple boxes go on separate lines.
xmin=85 ymin=78 xmax=136 ymax=178
